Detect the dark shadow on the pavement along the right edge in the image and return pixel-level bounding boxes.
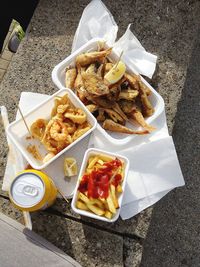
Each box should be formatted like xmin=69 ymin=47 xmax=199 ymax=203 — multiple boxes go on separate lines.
xmin=141 ymin=28 xmax=200 ymax=267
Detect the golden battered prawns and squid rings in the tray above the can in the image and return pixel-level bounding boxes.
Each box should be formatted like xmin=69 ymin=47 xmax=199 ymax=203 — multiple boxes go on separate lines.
xmin=28 ymin=94 xmax=91 ymax=162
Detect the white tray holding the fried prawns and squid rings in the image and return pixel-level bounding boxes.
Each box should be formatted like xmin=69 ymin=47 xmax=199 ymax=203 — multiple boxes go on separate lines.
xmin=6 ymin=89 xmax=97 ymax=170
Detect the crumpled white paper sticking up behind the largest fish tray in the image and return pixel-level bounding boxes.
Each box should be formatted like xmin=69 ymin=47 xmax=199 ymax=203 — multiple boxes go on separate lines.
xmin=72 ymin=0 xmax=157 ymax=78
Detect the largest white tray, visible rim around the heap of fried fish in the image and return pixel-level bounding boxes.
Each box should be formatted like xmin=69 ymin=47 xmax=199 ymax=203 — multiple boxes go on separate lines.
xmin=52 ymin=38 xmax=164 ymax=144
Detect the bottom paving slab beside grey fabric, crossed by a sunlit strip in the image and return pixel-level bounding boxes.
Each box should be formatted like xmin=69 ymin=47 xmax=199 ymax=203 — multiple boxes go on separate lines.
xmin=32 ymin=212 xmax=123 ymax=267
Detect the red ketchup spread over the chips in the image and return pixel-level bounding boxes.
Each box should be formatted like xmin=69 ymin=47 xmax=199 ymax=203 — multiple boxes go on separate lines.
xmin=78 ymin=158 xmax=122 ymax=198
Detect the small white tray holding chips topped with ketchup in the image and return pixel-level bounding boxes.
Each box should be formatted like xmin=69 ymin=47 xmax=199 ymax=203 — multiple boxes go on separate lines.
xmin=71 ymin=148 xmax=129 ymax=222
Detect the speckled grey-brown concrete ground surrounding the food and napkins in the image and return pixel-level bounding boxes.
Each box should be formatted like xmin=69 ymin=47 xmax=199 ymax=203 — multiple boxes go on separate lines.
xmin=0 ymin=0 xmax=200 ymax=267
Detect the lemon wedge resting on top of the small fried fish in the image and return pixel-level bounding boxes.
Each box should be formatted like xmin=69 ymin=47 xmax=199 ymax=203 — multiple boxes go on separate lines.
xmin=104 ymin=61 xmax=126 ymax=84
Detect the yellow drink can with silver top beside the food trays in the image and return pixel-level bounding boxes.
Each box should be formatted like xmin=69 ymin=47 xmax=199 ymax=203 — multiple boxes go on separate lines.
xmin=9 ymin=169 xmax=58 ymax=212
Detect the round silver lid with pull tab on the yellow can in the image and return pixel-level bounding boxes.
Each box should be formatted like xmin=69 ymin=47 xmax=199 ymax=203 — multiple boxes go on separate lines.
xmin=10 ymin=172 xmax=44 ymax=208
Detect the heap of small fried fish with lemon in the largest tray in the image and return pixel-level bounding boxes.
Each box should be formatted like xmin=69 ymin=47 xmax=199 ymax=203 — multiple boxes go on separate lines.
xmin=65 ymin=43 xmax=155 ymax=136
